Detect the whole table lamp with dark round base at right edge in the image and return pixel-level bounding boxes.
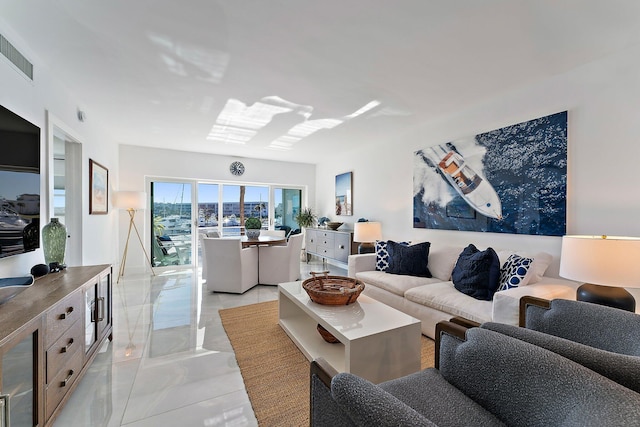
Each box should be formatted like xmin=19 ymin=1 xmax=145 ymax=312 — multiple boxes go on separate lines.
xmin=560 ymin=236 xmax=640 ymax=312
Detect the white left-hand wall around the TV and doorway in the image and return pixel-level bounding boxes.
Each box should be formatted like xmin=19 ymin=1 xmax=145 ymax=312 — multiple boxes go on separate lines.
xmin=0 ymin=19 xmax=118 ymax=277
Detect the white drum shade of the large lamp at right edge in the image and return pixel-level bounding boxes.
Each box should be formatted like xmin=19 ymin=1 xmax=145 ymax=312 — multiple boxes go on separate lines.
xmin=560 ymin=236 xmax=640 ymax=288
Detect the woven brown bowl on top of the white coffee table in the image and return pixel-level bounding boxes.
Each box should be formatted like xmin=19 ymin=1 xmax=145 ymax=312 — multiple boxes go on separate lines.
xmin=302 ymin=271 xmax=364 ymax=305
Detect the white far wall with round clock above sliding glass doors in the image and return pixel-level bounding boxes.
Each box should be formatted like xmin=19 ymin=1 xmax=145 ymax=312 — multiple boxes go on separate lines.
xmin=119 ymin=143 xmax=316 ymax=271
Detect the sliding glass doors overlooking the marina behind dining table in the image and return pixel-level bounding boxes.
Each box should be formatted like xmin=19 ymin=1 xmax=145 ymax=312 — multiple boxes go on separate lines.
xmin=149 ymin=180 xmax=302 ymax=267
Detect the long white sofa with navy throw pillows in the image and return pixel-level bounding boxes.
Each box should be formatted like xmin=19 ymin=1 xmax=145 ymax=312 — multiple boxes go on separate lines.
xmin=348 ymin=245 xmax=580 ymax=338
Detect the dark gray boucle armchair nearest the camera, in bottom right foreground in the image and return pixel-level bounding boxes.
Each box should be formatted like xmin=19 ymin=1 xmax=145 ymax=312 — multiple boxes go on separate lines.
xmin=311 ymin=322 xmax=640 ymax=427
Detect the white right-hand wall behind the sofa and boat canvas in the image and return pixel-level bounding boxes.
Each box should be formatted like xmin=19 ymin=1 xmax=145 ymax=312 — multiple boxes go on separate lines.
xmin=316 ymin=43 xmax=640 ymax=274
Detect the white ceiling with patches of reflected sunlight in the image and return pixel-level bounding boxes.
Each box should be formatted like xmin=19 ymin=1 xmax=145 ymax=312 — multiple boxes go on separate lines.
xmin=0 ymin=0 xmax=640 ymax=162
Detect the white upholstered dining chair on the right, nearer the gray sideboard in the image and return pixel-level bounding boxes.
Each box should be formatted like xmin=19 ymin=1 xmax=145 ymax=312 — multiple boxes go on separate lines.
xmin=260 ymin=234 xmax=304 ymax=285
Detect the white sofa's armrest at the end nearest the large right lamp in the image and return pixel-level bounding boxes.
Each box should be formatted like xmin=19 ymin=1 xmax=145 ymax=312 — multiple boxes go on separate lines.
xmin=491 ymin=277 xmax=580 ymax=326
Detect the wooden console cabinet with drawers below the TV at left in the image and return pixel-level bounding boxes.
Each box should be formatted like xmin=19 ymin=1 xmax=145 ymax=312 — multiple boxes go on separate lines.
xmin=0 ymin=265 xmax=113 ymax=427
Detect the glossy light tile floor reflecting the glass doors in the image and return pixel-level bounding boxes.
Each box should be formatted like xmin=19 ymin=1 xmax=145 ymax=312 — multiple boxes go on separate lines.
xmin=54 ymin=260 xmax=346 ymax=427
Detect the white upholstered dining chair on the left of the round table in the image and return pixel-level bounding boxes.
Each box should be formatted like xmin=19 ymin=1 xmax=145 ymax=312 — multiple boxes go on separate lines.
xmin=202 ymin=237 xmax=258 ymax=294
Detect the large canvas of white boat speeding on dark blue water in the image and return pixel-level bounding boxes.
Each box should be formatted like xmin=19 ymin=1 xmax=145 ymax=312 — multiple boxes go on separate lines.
xmin=413 ymin=111 xmax=567 ymax=236
